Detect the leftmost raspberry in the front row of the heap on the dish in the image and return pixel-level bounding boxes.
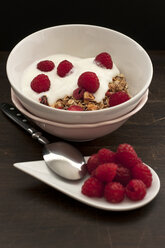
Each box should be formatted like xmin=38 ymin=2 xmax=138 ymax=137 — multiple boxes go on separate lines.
xmin=81 ymin=177 xmax=104 ymax=197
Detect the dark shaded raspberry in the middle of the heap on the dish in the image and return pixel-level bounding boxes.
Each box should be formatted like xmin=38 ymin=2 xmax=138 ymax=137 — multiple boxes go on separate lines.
xmin=114 ymin=166 xmax=131 ymax=186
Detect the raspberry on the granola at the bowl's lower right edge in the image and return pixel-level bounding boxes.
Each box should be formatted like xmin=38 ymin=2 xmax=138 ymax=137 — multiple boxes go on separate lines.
xmin=109 ymin=91 xmax=130 ymax=107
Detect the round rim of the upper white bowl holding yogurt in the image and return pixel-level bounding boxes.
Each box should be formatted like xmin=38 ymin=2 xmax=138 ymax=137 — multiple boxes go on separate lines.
xmin=6 ymin=24 xmax=153 ymax=116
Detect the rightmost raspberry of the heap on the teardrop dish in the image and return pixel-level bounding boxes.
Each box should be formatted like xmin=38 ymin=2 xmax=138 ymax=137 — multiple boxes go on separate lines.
xmin=132 ymin=163 xmax=152 ymax=188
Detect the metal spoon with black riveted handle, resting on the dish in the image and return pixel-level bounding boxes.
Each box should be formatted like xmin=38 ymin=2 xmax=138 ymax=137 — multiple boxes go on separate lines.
xmin=1 ymin=103 xmax=86 ymax=180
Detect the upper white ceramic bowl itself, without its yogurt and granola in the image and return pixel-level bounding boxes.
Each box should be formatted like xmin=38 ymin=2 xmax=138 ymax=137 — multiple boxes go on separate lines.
xmin=7 ymin=24 xmax=153 ymax=124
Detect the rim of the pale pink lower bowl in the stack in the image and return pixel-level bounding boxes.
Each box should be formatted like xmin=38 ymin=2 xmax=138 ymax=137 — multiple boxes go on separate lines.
xmin=11 ymin=89 xmax=149 ymax=129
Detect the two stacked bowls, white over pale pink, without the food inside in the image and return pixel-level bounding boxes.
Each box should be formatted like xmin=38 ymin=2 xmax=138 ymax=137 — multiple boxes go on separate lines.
xmin=7 ymin=24 xmax=153 ymax=141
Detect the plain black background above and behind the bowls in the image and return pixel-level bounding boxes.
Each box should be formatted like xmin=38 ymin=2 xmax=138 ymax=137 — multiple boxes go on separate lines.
xmin=0 ymin=0 xmax=165 ymax=51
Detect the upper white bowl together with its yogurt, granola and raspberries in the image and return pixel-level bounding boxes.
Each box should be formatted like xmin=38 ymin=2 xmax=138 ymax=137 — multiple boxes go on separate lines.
xmin=7 ymin=24 xmax=153 ymax=124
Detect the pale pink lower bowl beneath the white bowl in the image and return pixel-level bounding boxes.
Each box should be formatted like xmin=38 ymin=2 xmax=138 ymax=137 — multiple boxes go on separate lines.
xmin=11 ymin=91 xmax=148 ymax=141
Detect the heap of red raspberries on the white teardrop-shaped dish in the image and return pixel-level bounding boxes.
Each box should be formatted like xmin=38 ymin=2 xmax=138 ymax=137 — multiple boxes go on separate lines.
xmin=81 ymin=143 xmax=152 ymax=203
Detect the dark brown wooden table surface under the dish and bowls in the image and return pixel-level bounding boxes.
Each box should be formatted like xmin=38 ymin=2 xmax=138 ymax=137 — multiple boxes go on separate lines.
xmin=0 ymin=51 xmax=165 ymax=248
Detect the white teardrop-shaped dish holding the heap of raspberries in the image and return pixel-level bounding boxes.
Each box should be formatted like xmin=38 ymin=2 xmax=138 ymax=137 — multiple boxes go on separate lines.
xmin=14 ymin=157 xmax=160 ymax=211
